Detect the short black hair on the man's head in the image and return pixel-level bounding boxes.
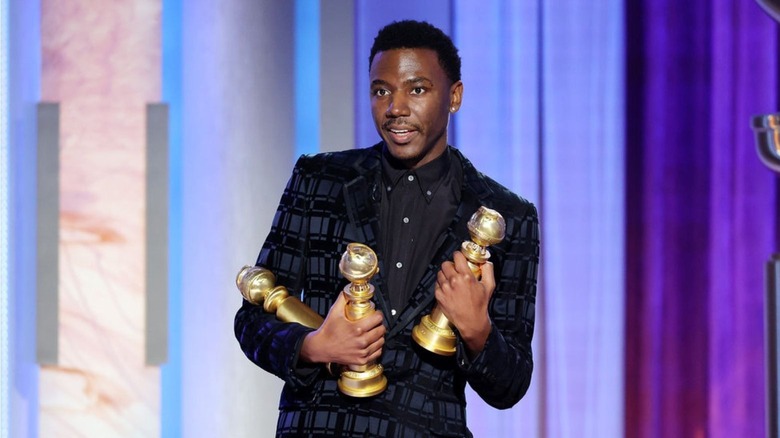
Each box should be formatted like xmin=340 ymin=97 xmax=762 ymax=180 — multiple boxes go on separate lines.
xmin=368 ymin=20 xmax=460 ymax=83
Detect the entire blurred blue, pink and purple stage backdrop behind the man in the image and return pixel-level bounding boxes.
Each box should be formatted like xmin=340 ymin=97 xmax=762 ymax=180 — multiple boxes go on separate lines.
xmin=0 ymin=0 xmax=780 ymax=438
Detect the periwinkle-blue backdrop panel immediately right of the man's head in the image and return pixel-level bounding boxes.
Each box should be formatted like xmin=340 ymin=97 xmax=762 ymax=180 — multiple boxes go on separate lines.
xmin=451 ymin=1 xmax=546 ymax=436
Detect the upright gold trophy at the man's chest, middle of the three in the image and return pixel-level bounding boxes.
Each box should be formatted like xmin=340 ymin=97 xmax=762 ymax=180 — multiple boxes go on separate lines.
xmin=338 ymin=243 xmax=387 ymax=397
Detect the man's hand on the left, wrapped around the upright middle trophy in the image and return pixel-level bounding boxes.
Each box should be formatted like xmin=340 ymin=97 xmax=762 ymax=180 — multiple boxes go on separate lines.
xmin=300 ymin=293 xmax=386 ymax=365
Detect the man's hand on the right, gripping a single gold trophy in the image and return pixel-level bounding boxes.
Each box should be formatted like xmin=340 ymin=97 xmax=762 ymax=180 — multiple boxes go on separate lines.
xmin=435 ymin=251 xmax=496 ymax=358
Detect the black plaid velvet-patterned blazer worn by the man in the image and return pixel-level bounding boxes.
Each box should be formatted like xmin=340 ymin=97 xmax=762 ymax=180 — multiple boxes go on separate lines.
xmin=235 ymin=143 xmax=539 ymax=437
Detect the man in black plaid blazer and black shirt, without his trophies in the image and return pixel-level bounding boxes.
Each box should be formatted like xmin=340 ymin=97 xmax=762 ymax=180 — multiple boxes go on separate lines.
xmin=235 ymin=21 xmax=539 ymax=437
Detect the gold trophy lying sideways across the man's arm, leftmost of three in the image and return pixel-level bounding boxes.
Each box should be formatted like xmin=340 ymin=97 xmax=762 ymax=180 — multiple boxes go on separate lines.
xmin=236 ymin=266 xmax=323 ymax=329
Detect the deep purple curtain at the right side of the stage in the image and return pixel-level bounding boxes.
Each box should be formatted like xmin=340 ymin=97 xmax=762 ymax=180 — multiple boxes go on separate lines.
xmin=625 ymin=0 xmax=780 ymax=437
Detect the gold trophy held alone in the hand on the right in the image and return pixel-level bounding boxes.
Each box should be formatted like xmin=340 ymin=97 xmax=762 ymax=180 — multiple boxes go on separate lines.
xmin=412 ymin=206 xmax=506 ymax=356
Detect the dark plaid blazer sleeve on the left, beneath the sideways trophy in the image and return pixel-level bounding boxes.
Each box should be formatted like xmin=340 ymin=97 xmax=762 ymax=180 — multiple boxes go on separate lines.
xmin=234 ymin=156 xmax=321 ymax=389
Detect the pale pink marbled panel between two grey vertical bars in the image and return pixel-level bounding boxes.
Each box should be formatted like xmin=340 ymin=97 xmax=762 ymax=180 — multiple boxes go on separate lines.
xmin=40 ymin=0 xmax=161 ymax=436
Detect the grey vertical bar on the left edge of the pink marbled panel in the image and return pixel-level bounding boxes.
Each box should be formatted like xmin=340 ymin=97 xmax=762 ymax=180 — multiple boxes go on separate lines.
xmin=35 ymin=103 xmax=60 ymax=365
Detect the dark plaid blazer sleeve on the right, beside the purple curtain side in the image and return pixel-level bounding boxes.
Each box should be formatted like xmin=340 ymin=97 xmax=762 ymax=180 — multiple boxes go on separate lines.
xmin=457 ymin=204 xmax=539 ymax=409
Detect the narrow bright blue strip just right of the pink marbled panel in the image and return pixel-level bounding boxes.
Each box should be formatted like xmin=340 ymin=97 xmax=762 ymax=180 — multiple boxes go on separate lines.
xmin=160 ymin=0 xmax=184 ymax=438
